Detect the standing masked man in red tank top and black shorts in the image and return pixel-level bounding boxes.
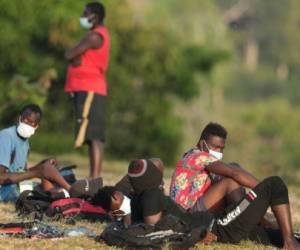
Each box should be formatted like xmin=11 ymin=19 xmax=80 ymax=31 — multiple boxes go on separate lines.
xmin=65 ymin=2 xmax=110 ymax=178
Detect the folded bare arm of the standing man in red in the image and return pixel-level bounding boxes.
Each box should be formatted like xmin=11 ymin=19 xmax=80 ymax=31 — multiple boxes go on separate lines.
xmin=65 ymin=31 xmax=103 ymax=61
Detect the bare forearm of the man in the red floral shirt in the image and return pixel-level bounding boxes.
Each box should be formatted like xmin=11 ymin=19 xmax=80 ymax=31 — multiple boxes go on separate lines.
xmin=206 ymin=161 xmax=259 ymax=188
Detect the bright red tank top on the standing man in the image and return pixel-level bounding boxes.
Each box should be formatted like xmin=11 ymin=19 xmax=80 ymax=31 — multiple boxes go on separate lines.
xmin=65 ymin=26 xmax=110 ymax=96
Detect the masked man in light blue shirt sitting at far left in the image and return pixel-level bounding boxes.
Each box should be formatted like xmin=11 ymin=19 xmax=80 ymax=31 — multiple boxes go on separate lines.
xmin=0 ymin=104 xmax=70 ymax=202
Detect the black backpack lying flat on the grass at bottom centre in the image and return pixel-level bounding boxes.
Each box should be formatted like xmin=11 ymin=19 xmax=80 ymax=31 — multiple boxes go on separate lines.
xmin=96 ymin=215 xmax=206 ymax=249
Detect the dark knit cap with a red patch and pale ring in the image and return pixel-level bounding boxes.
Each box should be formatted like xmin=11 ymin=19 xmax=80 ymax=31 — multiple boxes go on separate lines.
xmin=128 ymin=159 xmax=163 ymax=194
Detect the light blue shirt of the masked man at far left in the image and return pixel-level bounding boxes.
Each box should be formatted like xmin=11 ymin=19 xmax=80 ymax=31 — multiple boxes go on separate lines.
xmin=0 ymin=126 xmax=29 ymax=202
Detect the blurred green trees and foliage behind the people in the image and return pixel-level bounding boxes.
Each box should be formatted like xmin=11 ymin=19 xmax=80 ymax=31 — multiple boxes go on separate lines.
xmin=0 ymin=0 xmax=300 ymax=180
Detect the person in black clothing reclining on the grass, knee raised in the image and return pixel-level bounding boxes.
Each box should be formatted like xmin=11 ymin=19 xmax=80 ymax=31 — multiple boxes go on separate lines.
xmin=94 ymin=159 xmax=300 ymax=249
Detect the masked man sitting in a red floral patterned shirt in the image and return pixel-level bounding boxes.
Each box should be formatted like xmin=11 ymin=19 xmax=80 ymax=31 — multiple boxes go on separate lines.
xmin=170 ymin=123 xmax=258 ymax=213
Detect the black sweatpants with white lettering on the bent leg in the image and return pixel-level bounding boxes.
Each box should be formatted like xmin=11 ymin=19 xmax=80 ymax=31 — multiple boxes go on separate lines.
xmin=212 ymin=176 xmax=289 ymax=244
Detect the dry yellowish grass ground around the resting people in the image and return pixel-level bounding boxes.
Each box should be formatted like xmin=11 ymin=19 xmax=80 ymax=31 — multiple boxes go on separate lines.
xmin=0 ymin=155 xmax=300 ymax=250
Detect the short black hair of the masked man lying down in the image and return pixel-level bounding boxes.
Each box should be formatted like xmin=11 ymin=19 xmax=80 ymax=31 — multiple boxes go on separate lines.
xmin=92 ymin=186 xmax=117 ymax=211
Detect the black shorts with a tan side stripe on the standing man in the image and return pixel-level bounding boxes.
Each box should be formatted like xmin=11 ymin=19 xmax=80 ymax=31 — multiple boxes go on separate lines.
xmin=73 ymin=92 xmax=106 ymax=147
